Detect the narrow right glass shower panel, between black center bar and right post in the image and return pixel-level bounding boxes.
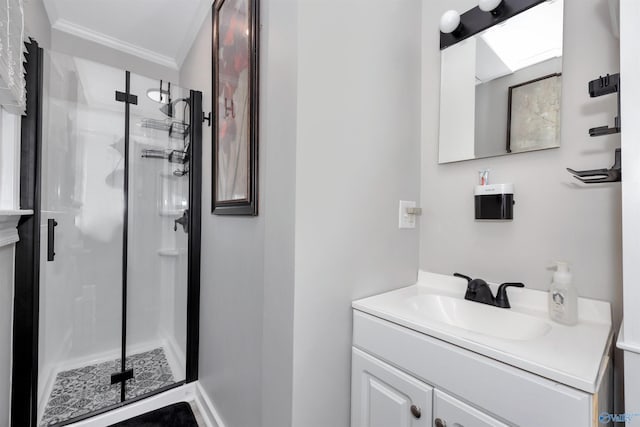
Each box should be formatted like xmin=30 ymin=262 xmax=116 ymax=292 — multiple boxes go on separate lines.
xmin=120 ymin=73 xmax=190 ymax=398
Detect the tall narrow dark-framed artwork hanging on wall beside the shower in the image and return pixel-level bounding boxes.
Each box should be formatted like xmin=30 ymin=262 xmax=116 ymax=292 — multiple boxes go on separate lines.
xmin=211 ymin=0 xmax=259 ymax=215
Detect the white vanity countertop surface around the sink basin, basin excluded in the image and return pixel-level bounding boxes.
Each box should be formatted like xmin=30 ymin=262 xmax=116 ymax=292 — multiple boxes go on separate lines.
xmin=352 ymin=271 xmax=612 ymax=393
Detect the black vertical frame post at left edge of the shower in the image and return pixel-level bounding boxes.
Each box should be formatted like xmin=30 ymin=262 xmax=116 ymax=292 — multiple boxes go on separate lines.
xmin=11 ymin=39 xmax=43 ymax=427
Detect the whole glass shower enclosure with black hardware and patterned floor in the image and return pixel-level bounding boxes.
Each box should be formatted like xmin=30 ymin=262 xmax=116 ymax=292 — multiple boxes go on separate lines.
xmin=13 ymin=48 xmax=202 ymax=426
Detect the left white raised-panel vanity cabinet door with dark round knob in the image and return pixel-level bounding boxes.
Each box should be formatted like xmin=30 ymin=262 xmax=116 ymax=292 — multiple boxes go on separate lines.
xmin=351 ymin=348 xmax=433 ymax=427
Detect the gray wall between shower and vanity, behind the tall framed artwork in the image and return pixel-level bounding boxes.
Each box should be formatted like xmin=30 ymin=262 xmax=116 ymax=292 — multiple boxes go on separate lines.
xmin=180 ymin=0 xmax=420 ymax=427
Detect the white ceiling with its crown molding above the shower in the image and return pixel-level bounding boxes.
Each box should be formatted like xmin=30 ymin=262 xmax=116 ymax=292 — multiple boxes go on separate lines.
xmin=44 ymin=0 xmax=213 ymax=69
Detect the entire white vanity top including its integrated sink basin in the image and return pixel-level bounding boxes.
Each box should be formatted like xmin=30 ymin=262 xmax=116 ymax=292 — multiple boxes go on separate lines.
xmin=353 ymin=271 xmax=611 ymax=393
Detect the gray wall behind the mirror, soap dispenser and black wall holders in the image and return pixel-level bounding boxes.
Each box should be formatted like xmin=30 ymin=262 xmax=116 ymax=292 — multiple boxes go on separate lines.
xmin=420 ymin=0 xmax=622 ymax=323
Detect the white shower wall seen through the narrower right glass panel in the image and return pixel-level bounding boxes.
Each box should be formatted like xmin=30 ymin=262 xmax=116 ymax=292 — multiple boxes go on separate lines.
xmin=127 ymin=74 xmax=189 ymax=380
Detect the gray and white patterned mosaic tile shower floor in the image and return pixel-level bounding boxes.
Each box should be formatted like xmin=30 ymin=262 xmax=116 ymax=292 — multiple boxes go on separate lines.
xmin=40 ymin=348 xmax=175 ymax=427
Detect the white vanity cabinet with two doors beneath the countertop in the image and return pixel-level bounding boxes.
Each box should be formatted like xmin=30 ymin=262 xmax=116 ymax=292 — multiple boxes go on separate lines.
xmin=351 ymin=310 xmax=611 ymax=427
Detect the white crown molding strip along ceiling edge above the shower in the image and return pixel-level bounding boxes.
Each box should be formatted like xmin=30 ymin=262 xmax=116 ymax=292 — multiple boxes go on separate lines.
xmin=51 ymin=19 xmax=178 ymax=70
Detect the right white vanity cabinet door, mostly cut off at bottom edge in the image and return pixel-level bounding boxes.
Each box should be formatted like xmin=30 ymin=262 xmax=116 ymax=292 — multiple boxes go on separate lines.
xmin=433 ymin=390 xmax=507 ymax=427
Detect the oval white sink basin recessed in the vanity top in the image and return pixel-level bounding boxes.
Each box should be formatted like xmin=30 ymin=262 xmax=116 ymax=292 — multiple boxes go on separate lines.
xmin=407 ymin=294 xmax=551 ymax=340
